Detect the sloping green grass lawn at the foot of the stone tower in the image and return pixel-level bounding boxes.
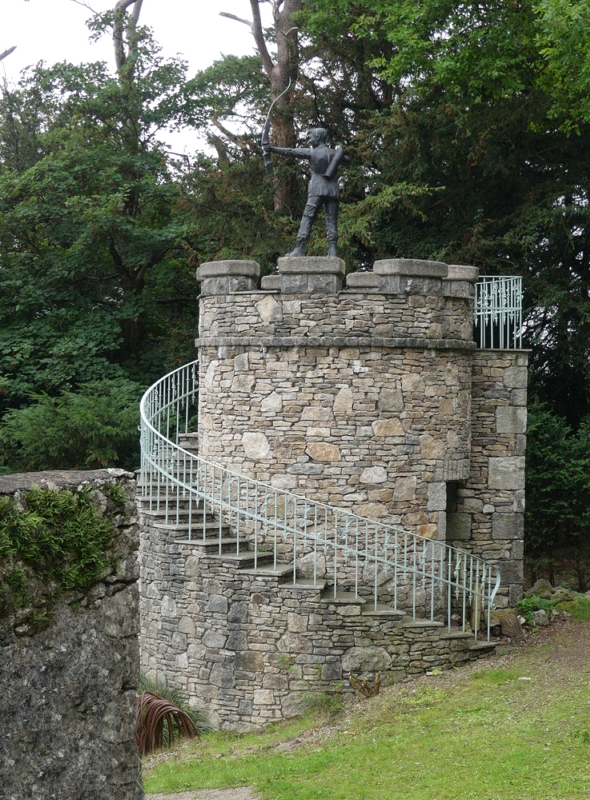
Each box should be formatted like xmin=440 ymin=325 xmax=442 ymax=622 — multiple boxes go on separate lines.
xmin=145 ymin=622 xmax=590 ymax=800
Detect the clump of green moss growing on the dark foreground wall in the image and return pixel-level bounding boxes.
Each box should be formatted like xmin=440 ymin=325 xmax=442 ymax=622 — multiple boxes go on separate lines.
xmin=0 ymin=486 xmax=115 ymax=625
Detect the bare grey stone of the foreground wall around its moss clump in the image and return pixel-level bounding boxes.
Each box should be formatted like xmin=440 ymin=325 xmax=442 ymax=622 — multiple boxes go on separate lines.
xmin=0 ymin=470 xmax=143 ymax=800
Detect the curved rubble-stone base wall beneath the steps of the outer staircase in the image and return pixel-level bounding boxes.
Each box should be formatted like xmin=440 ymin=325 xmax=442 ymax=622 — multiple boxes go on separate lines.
xmin=141 ymin=517 xmax=494 ymax=731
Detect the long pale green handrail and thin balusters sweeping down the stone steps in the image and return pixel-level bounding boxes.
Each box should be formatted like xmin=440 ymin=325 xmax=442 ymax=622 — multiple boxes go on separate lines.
xmin=140 ymin=361 xmax=500 ymax=638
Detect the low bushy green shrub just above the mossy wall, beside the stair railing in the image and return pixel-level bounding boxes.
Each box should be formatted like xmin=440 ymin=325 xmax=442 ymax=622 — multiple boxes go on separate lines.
xmin=0 ymin=378 xmax=141 ymax=472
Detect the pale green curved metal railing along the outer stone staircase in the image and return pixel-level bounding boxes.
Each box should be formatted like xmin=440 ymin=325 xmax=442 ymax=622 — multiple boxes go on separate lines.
xmin=141 ymin=361 xmax=500 ymax=639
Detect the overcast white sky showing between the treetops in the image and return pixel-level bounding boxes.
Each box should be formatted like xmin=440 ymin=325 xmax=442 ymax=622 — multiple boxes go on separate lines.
xmin=0 ymin=0 xmax=268 ymax=149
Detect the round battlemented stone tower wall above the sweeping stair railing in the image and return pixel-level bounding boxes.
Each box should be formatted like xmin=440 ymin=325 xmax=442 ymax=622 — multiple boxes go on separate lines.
xmin=197 ymin=258 xmax=477 ymax=538
